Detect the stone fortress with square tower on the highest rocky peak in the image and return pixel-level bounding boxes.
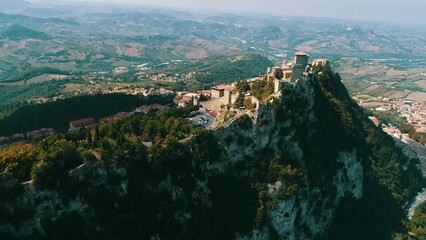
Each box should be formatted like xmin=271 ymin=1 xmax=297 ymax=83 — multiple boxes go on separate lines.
xmin=266 ymin=52 xmax=328 ymax=93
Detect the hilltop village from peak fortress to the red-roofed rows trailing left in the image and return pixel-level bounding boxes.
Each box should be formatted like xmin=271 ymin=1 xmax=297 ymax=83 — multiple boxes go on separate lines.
xmin=0 ymin=52 xmax=328 ymax=147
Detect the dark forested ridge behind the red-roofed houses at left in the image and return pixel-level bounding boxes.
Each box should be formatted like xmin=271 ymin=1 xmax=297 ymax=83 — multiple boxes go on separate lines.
xmin=0 ymin=94 xmax=172 ymax=136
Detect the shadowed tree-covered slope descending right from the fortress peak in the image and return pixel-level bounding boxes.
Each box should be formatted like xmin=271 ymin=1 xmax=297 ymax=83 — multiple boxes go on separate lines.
xmin=311 ymin=65 xmax=425 ymax=239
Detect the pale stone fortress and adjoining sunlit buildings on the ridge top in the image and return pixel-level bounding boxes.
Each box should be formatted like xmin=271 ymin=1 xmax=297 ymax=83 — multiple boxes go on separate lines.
xmin=168 ymin=52 xmax=328 ymax=129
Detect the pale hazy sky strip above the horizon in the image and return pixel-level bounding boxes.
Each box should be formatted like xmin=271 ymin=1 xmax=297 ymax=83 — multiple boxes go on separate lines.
xmin=29 ymin=0 xmax=426 ymax=24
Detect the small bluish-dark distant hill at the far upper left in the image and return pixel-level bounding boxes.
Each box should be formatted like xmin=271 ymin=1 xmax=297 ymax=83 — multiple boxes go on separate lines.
xmin=0 ymin=24 xmax=50 ymax=41
